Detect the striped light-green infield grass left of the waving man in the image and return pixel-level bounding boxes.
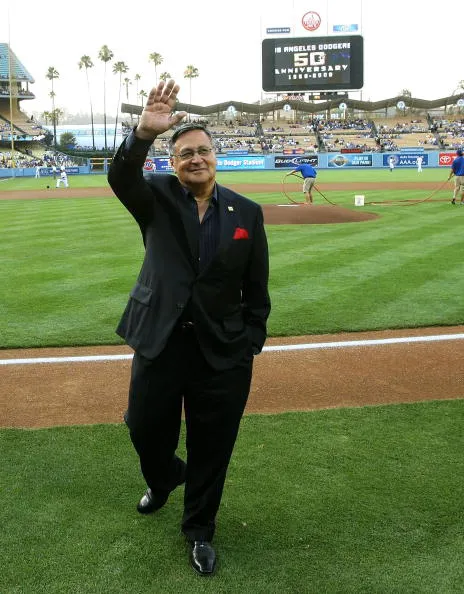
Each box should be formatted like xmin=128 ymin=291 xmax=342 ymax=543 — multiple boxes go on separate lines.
xmin=0 ymin=199 xmax=143 ymax=347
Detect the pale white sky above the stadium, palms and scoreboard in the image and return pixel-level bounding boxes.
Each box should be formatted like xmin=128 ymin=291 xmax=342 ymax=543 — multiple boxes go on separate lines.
xmin=0 ymin=0 xmax=464 ymax=115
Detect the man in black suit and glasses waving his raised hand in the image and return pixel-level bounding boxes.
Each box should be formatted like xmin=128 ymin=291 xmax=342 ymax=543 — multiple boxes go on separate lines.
xmin=108 ymin=80 xmax=270 ymax=575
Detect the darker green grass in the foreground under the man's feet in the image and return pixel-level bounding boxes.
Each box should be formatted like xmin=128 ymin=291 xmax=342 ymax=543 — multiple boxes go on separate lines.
xmin=0 ymin=400 xmax=464 ymax=594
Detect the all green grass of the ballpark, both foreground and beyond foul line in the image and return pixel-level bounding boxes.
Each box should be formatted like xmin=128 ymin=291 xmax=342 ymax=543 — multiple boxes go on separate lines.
xmin=0 ymin=165 xmax=464 ymax=594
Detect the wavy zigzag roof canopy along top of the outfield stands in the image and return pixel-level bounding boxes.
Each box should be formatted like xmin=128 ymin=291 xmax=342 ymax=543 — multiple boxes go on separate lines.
xmin=121 ymin=93 xmax=464 ymax=116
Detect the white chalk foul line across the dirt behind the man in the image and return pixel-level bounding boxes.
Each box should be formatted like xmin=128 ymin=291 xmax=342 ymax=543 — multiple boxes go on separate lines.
xmin=0 ymin=333 xmax=464 ymax=365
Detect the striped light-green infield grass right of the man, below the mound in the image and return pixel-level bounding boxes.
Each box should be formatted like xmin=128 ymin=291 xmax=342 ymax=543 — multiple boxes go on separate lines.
xmin=271 ymin=206 xmax=464 ymax=335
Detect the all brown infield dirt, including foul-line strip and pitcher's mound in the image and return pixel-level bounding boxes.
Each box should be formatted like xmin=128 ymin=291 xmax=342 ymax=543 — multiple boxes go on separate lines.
xmin=0 ymin=178 xmax=464 ymax=427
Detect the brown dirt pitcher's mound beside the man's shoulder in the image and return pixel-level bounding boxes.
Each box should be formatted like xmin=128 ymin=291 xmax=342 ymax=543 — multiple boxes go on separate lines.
xmin=263 ymin=204 xmax=379 ymax=225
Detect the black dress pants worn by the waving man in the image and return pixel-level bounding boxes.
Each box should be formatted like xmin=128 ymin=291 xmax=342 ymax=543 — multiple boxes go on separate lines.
xmin=126 ymin=326 xmax=253 ymax=541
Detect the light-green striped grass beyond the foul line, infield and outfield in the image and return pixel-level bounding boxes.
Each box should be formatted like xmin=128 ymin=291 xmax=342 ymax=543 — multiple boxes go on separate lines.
xmin=0 ymin=170 xmax=464 ymax=348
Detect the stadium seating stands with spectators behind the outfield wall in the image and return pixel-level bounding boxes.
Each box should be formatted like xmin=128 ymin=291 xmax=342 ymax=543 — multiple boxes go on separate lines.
xmin=0 ymin=43 xmax=464 ymax=161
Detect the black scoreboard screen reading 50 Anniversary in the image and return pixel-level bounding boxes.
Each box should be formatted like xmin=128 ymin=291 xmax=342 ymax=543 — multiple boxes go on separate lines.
xmin=262 ymin=35 xmax=364 ymax=93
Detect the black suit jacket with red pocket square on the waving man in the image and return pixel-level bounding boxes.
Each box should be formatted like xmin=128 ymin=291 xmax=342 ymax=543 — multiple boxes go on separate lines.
xmin=108 ymin=137 xmax=270 ymax=369
